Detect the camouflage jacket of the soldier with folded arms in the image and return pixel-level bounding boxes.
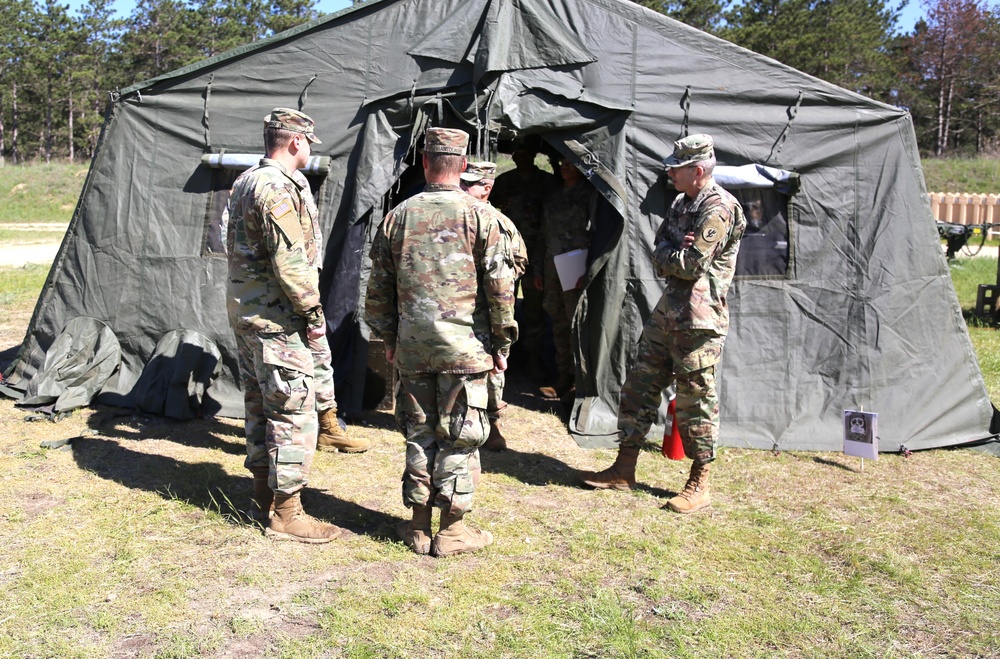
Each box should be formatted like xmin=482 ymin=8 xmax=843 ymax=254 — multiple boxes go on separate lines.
xmin=653 ymin=180 xmax=747 ymax=336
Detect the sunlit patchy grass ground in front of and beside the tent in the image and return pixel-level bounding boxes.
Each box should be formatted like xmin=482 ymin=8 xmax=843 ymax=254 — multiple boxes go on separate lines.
xmin=0 ymin=162 xmax=1000 ymax=659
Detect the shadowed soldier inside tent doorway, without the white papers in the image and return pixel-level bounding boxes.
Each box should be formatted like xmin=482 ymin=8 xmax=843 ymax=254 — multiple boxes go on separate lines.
xmin=490 ymin=141 xmax=562 ymax=384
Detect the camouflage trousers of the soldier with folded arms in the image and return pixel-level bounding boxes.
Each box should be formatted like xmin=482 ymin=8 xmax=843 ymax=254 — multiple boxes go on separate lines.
xmin=618 ymin=322 xmax=726 ymax=464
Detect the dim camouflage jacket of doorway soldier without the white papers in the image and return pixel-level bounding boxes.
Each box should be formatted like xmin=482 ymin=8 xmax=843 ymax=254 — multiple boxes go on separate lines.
xmin=490 ymin=167 xmax=562 ymax=278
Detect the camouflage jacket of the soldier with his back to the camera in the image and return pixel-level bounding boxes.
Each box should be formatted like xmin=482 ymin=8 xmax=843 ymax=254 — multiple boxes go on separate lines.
xmin=365 ymin=184 xmax=517 ymax=373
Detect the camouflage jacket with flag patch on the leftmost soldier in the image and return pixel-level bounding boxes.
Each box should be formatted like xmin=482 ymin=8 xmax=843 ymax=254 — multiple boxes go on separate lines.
xmin=226 ymin=158 xmax=323 ymax=332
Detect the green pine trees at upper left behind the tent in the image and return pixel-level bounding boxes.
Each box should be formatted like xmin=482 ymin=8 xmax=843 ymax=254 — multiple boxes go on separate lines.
xmin=0 ymin=0 xmax=318 ymax=164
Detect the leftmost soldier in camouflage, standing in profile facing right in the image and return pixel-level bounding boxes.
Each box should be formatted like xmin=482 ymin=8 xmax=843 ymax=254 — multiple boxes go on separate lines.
xmin=226 ymin=108 xmax=340 ymax=543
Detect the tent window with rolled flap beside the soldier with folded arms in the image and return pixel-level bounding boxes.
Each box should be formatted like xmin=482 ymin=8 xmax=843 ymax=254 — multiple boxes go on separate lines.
xmin=714 ymin=165 xmax=798 ymax=277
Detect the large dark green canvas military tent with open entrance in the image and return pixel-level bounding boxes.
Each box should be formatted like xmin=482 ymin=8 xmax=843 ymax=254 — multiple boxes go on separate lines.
xmin=8 ymin=0 xmax=995 ymax=451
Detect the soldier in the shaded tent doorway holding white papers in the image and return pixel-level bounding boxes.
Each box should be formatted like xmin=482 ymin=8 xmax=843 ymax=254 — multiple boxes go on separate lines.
xmin=535 ymin=158 xmax=598 ymax=398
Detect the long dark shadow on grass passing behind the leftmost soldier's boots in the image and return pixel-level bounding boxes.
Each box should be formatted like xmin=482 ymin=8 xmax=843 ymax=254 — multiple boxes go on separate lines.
xmin=73 ymin=437 xmax=402 ymax=540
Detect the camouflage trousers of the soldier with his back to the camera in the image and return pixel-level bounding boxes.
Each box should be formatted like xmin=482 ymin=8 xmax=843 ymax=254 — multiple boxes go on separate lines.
xmin=396 ymin=373 xmax=489 ymax=515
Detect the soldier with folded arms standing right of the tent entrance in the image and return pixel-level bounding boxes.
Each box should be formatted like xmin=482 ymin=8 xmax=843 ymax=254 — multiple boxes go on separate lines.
xmin=583 ymin=135 xmax=746 ymax=513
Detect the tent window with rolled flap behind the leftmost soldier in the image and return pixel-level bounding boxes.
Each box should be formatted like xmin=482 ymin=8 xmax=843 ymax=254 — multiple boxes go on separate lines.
xmin=201 ymin=153 xmax=330 ymax=258
